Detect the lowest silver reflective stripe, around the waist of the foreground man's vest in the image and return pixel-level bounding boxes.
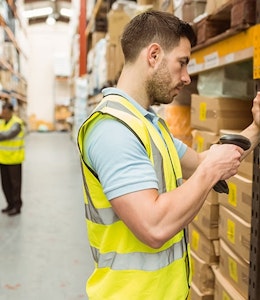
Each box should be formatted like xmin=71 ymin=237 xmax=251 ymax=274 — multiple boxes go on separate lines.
xmin=93 ymin=238 xmax=186 ymax=271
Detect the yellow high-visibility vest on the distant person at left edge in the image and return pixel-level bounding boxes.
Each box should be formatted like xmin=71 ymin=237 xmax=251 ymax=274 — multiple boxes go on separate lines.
xmin=0 ymin=115 xmax=25 ymax=165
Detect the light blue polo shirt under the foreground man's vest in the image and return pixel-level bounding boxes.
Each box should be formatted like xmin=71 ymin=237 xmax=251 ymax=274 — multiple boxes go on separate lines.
xmin=83 ymin=88 xmax=187 ymax=200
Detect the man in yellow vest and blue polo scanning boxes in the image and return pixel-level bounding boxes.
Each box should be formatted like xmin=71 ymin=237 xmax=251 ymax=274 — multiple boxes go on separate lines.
xmin=78 ymin=11 xmax=260 ymax=300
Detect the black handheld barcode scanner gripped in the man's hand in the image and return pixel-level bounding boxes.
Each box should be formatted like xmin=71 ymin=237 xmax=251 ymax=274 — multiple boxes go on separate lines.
xmin=213 ymin=134 xmax=251 ymax=194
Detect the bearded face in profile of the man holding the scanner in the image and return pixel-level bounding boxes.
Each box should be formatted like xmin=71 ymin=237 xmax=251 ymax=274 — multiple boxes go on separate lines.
xmin=146 ymin=38 xmax=191 ymax=104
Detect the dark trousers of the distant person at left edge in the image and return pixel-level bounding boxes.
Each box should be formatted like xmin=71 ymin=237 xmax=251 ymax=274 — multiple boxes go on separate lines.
xmin=0 ymin=164 xmax=22 ymax=208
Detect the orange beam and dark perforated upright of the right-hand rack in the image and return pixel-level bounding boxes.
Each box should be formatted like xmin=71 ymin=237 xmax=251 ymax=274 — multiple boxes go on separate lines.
xmin=189 ymin=14 xmax=260 ymax=300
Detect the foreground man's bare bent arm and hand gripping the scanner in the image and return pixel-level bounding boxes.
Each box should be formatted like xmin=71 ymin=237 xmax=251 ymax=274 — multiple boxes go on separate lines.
xmin=111 ymin=145 xmax=243 ymax=248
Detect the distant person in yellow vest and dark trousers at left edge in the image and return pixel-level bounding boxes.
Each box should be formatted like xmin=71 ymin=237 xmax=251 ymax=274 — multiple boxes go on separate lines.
xmin=0 ymin=102 xmax=25 ymax=216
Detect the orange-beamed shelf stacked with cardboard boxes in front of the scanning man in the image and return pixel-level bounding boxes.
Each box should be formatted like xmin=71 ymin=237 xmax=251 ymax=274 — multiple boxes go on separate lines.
xmin=189 ymin=0 xmax=260 ymax=300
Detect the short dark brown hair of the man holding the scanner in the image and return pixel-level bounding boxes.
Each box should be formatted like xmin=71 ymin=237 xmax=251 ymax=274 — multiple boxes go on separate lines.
xmin=121 ymin=10 xmax=196 ymax=62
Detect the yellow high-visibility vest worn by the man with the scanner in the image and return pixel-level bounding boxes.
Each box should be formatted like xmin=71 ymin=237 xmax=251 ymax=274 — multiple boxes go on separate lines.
xmin=78 ymin=95 xmax=191 ymax=300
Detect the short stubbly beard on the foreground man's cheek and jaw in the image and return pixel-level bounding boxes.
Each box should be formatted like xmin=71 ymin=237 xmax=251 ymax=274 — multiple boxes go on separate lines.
xmin=146 ymin=60 xmax=181 ymax=105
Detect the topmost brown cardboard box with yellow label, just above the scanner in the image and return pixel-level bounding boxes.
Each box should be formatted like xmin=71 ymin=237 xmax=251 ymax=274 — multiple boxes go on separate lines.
xmin=191 ymin=94 xmax=253 ymax=134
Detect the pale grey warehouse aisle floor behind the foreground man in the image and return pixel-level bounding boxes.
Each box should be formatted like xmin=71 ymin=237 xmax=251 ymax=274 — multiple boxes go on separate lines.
xmin=0 ymin=132 xmax=93 ymax=300
